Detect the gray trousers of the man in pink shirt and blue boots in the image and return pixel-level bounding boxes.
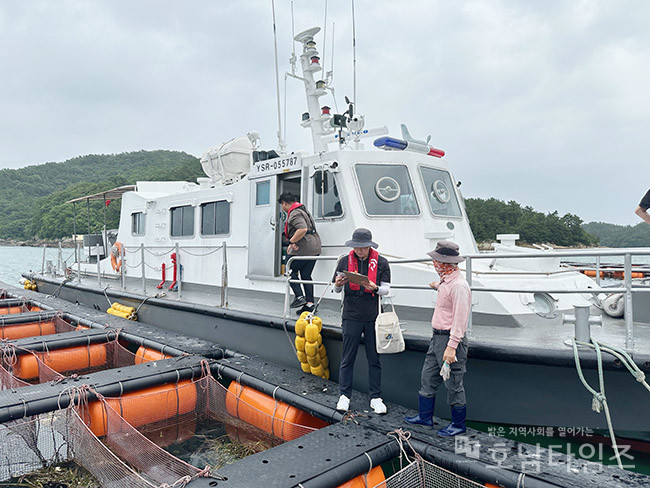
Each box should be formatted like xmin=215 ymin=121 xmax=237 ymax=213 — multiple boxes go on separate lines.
xmin=419 ymin=334 xmax=467 ymax=407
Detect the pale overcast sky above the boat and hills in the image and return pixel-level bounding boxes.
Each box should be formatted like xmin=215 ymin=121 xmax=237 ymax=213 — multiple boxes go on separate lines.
xmin=0 ymin=0 xmax=650 ymax=224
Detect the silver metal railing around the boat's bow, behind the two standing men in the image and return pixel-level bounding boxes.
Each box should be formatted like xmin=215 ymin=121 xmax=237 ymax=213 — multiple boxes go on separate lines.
xmin=284 ymin=248 xmax=650 ymax=350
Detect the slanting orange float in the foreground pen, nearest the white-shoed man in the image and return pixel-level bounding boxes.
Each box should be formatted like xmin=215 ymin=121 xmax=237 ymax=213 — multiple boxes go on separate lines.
xmin=226 ymin=381 xmax=329 ymax=441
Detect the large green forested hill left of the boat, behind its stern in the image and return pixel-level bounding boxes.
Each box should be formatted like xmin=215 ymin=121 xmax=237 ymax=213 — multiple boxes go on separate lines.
xmin=0 ymin=150 xmax=203 ymax=240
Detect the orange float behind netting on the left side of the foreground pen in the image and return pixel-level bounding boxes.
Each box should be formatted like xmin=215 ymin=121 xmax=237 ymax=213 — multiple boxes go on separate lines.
xmin=84 ymin=380 xmax=196 ymax=437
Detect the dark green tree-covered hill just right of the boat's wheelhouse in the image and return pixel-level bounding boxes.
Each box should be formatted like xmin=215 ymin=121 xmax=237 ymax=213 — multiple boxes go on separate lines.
xmin=465 ymin=198 xmax=598 ymax=246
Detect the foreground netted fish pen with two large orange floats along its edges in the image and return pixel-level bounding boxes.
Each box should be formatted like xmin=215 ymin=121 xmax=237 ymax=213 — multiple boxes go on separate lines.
xmin=0 ymin=374 xmax=329 ymax=487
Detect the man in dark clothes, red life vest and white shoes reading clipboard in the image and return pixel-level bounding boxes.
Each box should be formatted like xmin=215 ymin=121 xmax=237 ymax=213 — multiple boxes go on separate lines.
xmin=333 ymin=229 xmax=390 ymax=414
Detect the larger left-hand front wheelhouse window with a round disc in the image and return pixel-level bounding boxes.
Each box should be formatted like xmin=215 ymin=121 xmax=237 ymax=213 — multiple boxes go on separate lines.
xmin=355 ymin=164 xmax=420 ymax=215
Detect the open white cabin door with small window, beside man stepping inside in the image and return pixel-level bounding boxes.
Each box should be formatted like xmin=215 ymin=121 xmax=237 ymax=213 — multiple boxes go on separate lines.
xmin=247 ymin=170 xmax=302 ymax=279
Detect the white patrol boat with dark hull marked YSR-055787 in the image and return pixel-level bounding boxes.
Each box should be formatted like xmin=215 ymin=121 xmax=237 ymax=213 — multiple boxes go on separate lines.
xmin=22 ymin=28 xmax=650 ymax=435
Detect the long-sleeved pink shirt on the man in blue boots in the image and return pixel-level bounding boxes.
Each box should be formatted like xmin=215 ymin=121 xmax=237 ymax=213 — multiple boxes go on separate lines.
xmin=431 ymin=270 xmax=472 ymax=349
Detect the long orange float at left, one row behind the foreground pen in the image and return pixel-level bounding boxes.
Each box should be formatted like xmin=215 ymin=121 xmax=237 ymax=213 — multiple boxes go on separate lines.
xmin=13 ymin=344 xmax=106 ymax=380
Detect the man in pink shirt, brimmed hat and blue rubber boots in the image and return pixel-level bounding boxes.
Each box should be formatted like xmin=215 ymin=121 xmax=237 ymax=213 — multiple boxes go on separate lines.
xmin=405 ymin=241 xmax=472 ymax=437
